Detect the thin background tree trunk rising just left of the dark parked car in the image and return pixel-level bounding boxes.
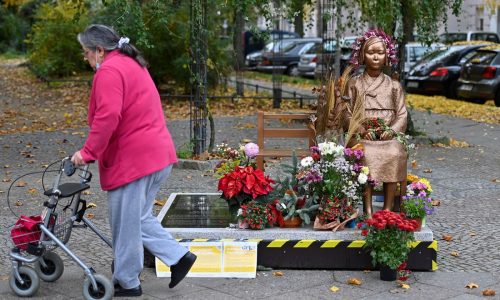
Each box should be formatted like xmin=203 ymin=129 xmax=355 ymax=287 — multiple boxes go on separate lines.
xmin=233 ymin=7 xmax=245 ymax=96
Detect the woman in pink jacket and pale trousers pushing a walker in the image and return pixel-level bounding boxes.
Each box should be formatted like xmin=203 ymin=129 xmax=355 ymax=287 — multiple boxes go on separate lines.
xmin=71 ymin=25 xmax=196 ymax=297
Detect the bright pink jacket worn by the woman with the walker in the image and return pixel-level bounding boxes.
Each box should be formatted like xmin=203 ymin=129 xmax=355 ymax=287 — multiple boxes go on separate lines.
xmin=81 ymin=50 xmax=177 ymax=191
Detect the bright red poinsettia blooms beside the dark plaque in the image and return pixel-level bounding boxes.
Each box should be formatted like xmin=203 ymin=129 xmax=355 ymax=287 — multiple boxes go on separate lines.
xmin=217 ymin=166 xmax=274 ymax=199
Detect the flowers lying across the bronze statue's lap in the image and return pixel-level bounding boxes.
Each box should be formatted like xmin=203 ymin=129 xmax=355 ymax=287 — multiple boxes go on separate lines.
xmin=356 ymin=118 xmax=415 ymax=153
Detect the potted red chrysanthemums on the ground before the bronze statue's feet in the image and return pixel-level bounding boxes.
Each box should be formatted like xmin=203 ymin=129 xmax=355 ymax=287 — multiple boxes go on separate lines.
xmin=358 ymin=210 xmax=417 ymax=281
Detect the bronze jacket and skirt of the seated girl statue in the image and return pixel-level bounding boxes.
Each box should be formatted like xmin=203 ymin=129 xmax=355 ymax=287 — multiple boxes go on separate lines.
xmin=345 ymin=72 xmax=407 ymax=182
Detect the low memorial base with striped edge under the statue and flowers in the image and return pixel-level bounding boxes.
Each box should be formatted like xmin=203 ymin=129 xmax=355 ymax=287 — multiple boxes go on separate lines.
xmin=150 ymin=194 xmax=437 ymax=271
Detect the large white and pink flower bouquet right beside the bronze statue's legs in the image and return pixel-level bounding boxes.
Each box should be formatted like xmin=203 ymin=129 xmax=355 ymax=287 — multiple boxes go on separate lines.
xmin=297 ymin=142 xmax=374 ymax=230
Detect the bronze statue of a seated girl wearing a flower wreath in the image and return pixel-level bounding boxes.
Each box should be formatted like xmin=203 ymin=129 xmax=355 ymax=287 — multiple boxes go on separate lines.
xmin=342 ymin=30 xmax=407 ymax=216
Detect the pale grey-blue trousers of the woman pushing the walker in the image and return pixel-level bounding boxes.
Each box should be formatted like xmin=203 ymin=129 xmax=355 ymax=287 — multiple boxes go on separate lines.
xmin=108 ymin=165 xmax=188 ymax=289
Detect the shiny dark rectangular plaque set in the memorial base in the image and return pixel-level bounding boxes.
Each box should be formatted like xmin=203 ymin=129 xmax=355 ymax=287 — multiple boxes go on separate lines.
xmin=161 ymin=194 xmax=231 ymax=228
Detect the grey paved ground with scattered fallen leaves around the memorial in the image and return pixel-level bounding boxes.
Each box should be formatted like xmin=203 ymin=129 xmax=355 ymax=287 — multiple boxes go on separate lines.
xmin=0 ymin=106 xmax=500 ymax=299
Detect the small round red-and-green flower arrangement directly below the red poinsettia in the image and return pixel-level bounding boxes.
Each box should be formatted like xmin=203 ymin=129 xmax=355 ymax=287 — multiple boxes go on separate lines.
xmin=238 ymin=200 xmax=273 ymax=229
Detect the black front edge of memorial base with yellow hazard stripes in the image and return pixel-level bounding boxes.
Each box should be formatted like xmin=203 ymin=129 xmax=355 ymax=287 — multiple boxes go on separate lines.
xmin=151 ymin=239 xmax=438 ymax=271
